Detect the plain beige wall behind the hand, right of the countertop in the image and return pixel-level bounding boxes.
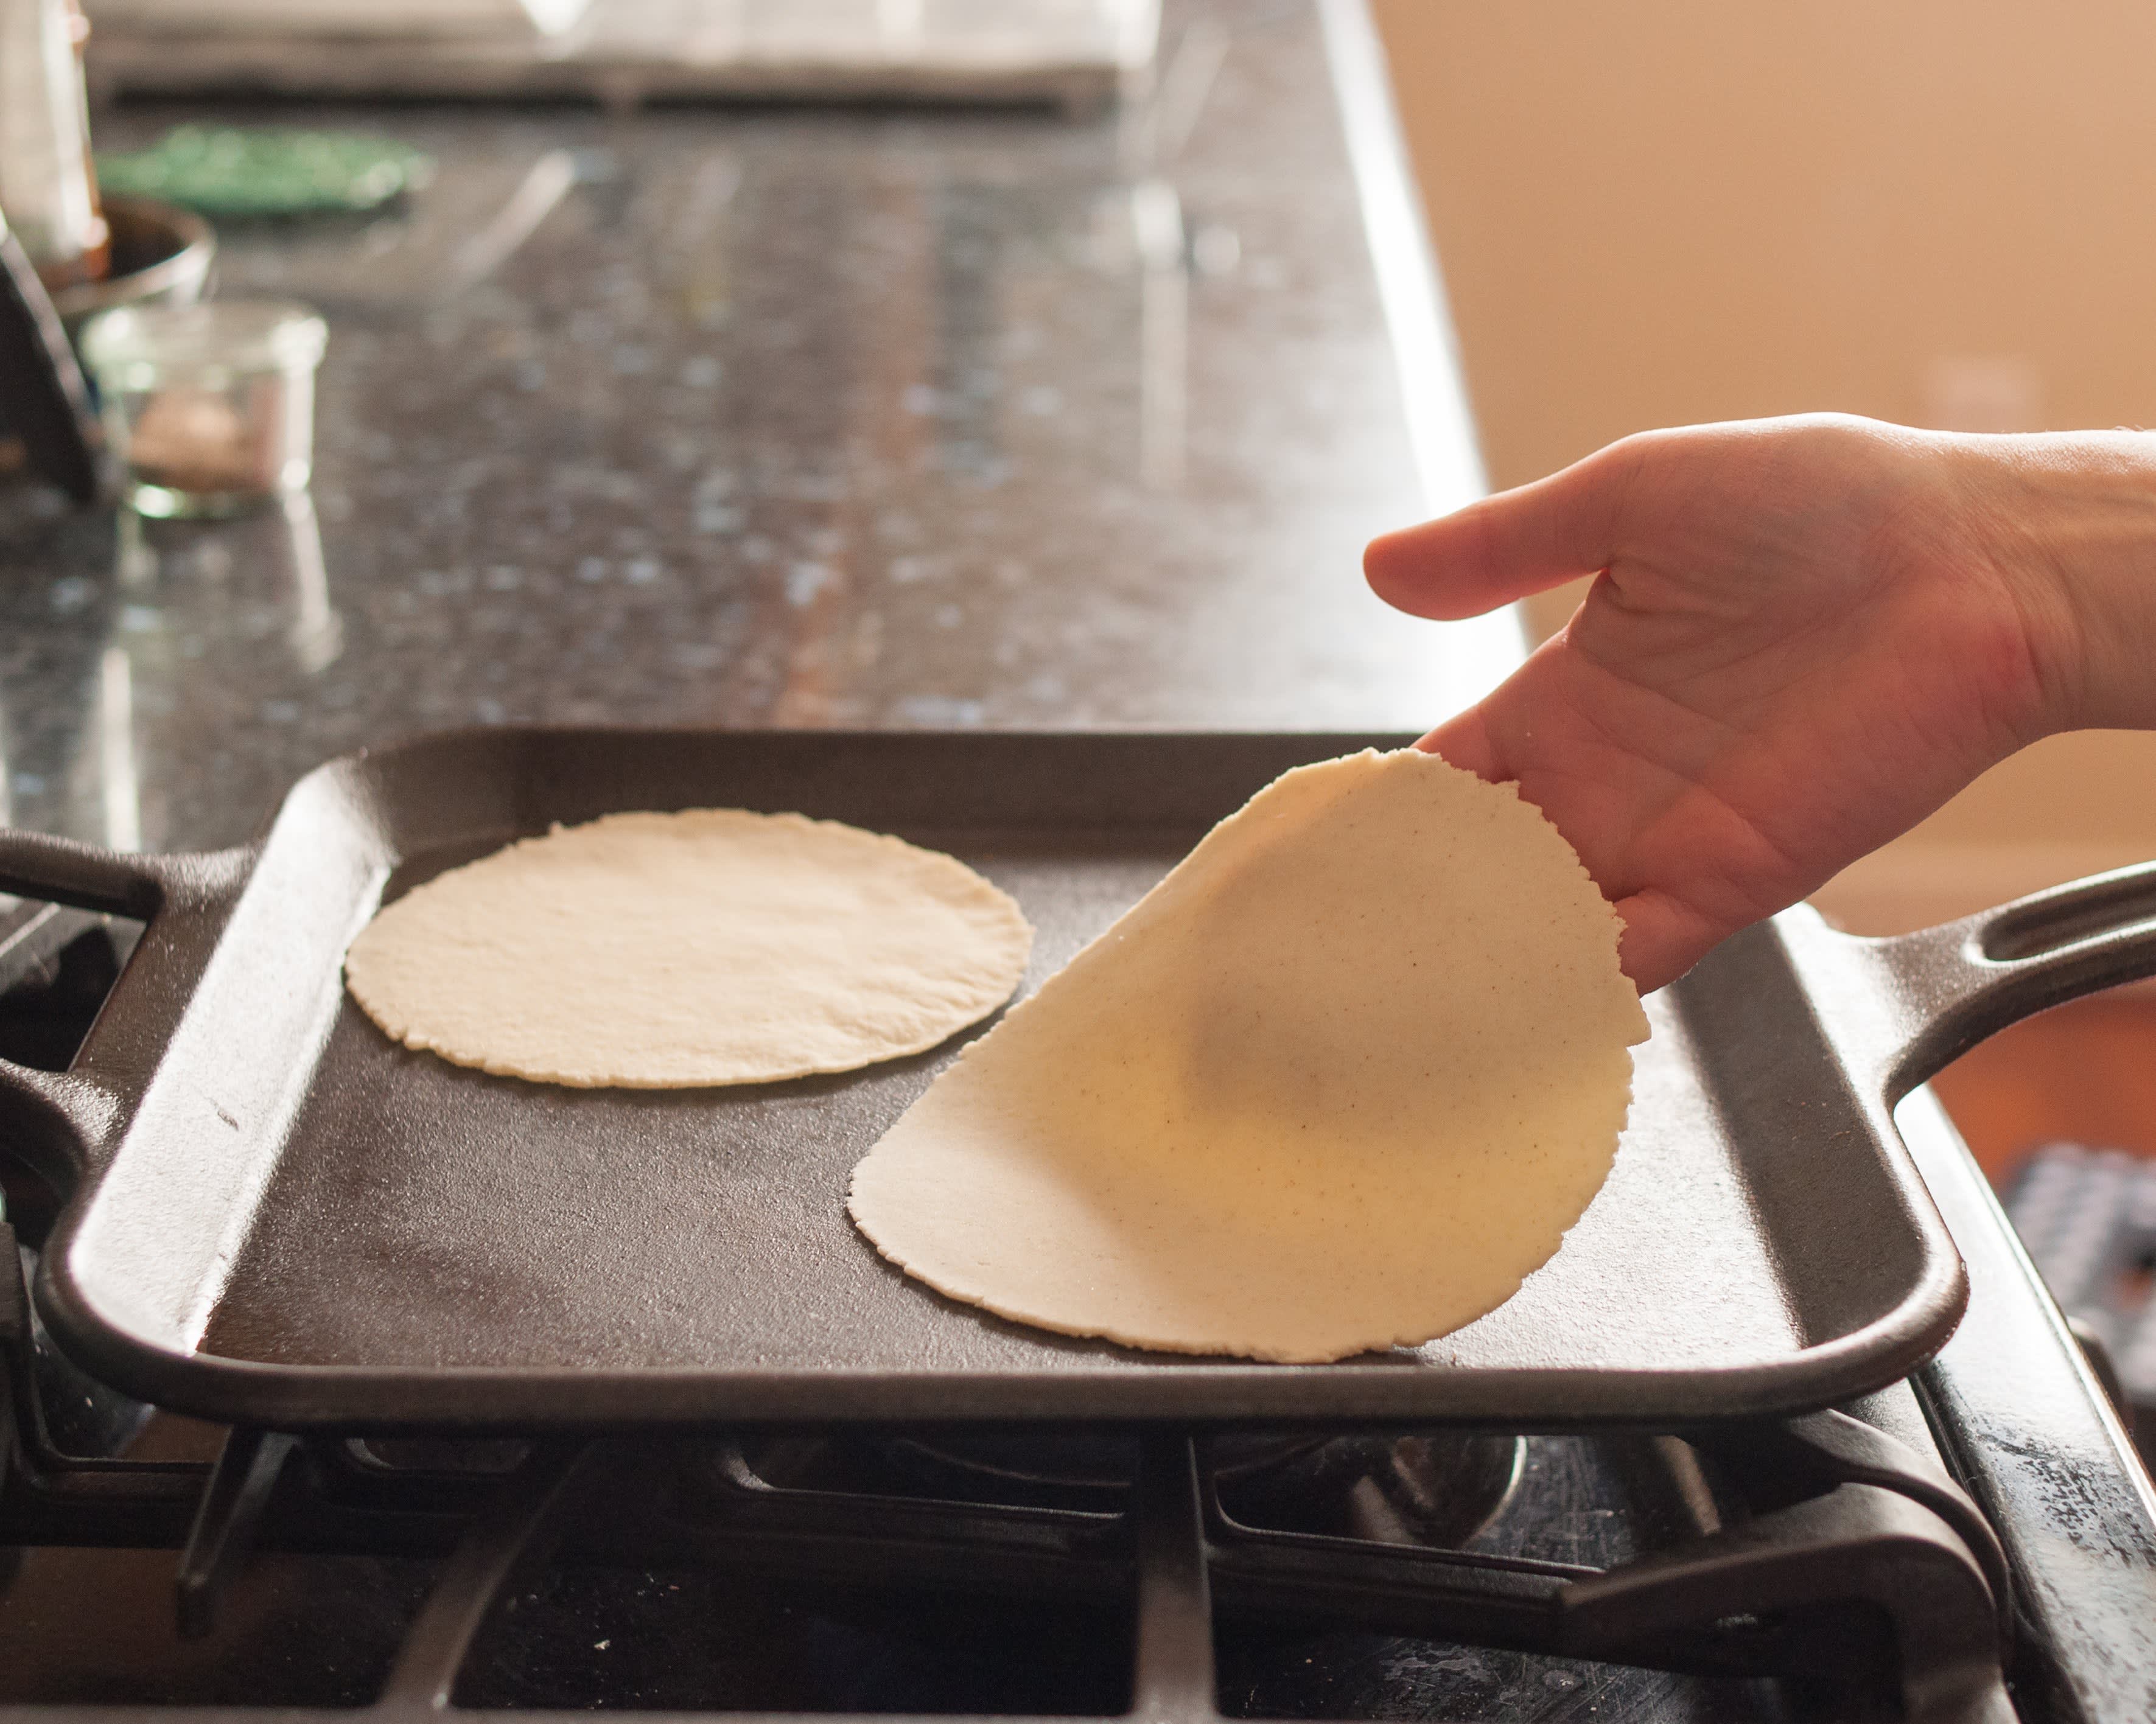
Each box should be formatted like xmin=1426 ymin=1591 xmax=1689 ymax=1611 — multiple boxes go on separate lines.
xmin=1373 ymin=0 xmax=2156 ymax=929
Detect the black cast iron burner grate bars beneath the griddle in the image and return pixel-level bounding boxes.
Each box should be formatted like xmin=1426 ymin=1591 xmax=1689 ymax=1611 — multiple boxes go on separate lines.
xmin=0 ymin=1239 xmax=2012 ymax=1724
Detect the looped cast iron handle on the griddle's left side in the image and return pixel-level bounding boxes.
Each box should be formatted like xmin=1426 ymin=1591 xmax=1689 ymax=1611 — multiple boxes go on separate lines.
xmin=0 ymin=832 xmax=252 ymax=1194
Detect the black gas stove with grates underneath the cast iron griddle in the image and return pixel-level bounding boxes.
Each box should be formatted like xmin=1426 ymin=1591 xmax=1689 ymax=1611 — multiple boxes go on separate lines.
xmin=0 ymin=909 xmax=2156 ymax=1720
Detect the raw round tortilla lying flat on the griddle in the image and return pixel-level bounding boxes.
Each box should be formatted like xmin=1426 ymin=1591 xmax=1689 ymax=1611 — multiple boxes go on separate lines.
xmin=345 ymin=808 xmax=1033 ymax=1088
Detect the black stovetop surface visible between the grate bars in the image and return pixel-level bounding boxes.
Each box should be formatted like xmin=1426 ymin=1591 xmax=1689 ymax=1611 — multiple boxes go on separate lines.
xmin=0 ymin=1416 xmax=1819 ymax=1720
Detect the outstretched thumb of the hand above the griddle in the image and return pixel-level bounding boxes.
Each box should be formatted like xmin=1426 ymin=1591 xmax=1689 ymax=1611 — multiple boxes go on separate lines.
xmin=1363 ymin=438 xmax=1647 ymax=621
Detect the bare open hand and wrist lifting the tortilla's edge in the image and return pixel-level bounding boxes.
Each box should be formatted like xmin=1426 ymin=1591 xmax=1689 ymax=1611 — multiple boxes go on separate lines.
xmin=1365 ymin=416 xmax=2156 ymax=991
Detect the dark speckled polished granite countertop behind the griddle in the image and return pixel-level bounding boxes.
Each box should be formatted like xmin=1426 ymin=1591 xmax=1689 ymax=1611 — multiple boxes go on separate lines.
xmin=0 ymin=2 xmax=1509 ymax=849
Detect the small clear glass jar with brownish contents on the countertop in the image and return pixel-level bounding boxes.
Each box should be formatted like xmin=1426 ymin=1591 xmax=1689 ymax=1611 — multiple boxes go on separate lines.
xmin=80 ymin=299 xmax=327 ymax=517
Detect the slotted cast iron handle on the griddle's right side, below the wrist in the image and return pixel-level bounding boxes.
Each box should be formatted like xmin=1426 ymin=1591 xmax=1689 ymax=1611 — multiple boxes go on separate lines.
xmin=1852 ymin=862 xmax=2156 ymax=1101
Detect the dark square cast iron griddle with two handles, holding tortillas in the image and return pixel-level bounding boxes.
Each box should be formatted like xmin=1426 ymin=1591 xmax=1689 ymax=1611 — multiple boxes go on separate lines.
xmin=0 ymin=730 xmax=2156 ymax=1429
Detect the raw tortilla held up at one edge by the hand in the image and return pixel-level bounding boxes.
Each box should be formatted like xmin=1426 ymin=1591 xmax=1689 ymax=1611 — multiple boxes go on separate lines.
xmin=850 ymin=750 xmax=1647 ymax=1360
